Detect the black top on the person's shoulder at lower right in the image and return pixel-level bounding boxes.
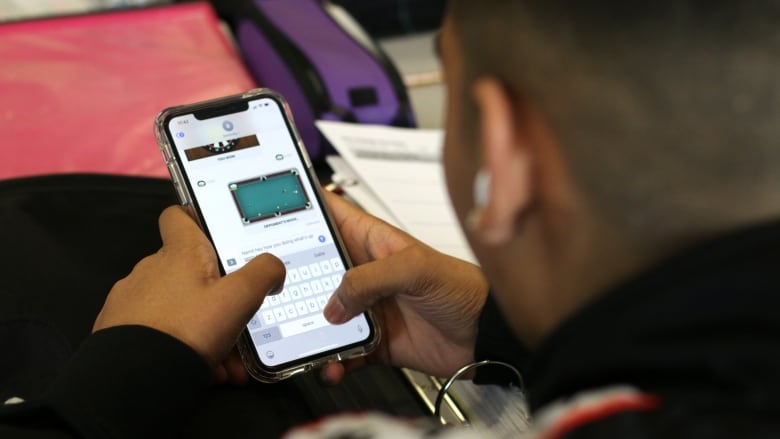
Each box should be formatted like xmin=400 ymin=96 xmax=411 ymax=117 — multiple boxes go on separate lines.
xmin=477 ymin=223 xmax=780 ymax=437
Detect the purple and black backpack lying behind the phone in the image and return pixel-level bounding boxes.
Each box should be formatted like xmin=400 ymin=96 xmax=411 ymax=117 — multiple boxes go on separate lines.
xmin=215 ymin=0 xmax=415 ymax=161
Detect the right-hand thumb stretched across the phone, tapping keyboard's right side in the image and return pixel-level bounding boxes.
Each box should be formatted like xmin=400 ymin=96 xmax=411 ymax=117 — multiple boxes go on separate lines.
xmin=323 ymin=246 xmax=422 ymax=324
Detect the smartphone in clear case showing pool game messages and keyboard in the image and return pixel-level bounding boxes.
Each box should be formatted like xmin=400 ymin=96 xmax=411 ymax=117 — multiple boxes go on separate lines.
xmin=155 ymin=89 xmax=379 ymax=382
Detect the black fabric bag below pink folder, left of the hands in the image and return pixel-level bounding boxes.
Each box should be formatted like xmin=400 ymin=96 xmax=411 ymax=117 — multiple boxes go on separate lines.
xmin=0 ymin=175 xmax=176 ymax=403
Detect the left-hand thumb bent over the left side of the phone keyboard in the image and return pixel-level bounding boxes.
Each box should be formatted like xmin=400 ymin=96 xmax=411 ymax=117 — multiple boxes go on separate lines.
xmin=220 ymin=253 xmax=286 ymax=325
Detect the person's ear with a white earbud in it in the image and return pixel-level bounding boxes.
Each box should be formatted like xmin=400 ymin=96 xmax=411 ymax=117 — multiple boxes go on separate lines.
xmin=471 ymin=77 xmax=533 ymax=246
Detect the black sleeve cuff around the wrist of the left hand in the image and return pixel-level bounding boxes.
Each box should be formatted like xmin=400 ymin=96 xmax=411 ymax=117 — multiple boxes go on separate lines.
xmin=0 ymin=326 xmax=213 ymax=438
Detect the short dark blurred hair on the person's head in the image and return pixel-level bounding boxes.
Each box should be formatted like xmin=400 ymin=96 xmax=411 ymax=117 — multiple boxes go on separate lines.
xmin=448 ymin=0 xmax=780 ymax=240
